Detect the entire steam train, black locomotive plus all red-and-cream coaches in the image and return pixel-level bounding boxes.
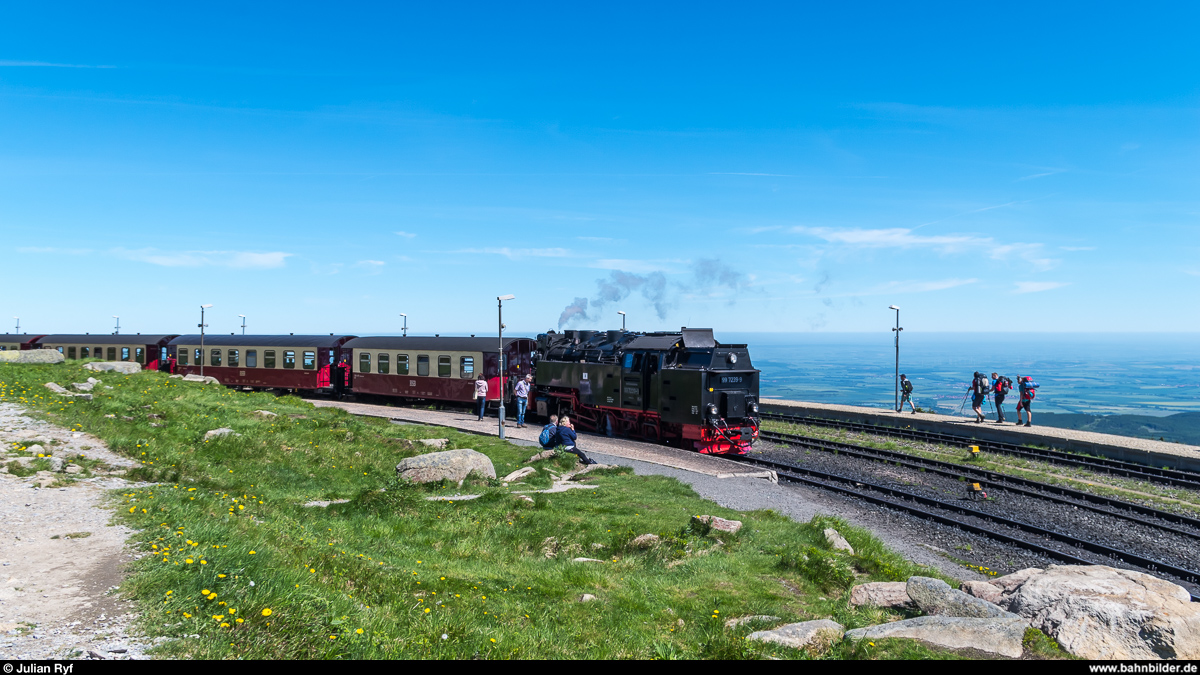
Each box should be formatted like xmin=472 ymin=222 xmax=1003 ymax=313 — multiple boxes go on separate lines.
xmin=11 ymin=328 xmax=758 ymax=454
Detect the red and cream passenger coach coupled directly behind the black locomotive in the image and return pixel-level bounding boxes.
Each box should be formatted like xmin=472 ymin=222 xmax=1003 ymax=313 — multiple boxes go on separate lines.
xmin=342 ymin=336 xmax=538 ymax=404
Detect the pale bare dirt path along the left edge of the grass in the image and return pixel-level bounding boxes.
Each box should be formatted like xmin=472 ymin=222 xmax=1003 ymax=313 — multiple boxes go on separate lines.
xmin=0 ymin=404 xmax=157 ymax=659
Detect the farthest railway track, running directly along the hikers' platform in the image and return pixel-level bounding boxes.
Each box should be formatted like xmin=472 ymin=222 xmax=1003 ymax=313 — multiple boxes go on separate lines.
xmin=761 ymin=412 xmax=1200 ymax=490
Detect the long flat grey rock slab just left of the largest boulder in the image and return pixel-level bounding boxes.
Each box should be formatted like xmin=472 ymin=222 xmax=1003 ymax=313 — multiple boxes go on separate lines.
xmin=846 ymin=616 xmax=1028 ymax=658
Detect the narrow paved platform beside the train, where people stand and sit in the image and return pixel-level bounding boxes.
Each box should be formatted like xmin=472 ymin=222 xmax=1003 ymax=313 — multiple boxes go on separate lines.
xmin=310 ymin=399 xmax=778 ymax=483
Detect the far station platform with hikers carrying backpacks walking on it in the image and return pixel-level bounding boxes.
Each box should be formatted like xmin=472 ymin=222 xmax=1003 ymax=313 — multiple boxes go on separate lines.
xmin=761 ymin=398 xmax=1200 ymax=471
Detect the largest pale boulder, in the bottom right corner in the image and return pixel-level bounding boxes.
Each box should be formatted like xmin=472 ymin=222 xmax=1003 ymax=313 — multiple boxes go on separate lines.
xmin=996 ymin=565 xmax=1200 ymax=661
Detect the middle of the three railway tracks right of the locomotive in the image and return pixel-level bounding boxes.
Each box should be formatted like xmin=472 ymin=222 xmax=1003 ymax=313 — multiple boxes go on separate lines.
xmin=758 ymin=431 xmax=1200 ymax=539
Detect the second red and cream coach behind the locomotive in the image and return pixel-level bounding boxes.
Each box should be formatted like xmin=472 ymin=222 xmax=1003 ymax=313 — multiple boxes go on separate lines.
xmin=167 ymin=335 xmax=353 ymax=392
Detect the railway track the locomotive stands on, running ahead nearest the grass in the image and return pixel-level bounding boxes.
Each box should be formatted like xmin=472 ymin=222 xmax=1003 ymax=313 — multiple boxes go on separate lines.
xmin=728 ymin=455 xmax=1200 ymax=602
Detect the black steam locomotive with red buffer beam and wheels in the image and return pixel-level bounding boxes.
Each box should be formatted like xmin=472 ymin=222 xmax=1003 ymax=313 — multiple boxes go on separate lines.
xmin=534 ymin=328 xmax=760 ymax=454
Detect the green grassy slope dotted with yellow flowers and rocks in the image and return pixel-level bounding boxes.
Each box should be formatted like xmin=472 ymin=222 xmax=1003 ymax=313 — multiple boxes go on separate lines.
xmin=0 ymin=363 xmax=1003 ymax=659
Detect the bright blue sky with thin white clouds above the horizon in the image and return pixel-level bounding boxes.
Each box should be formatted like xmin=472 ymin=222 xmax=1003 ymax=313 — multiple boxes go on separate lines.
xmin=0 ymin=2 xmax=1200 ymax=334
